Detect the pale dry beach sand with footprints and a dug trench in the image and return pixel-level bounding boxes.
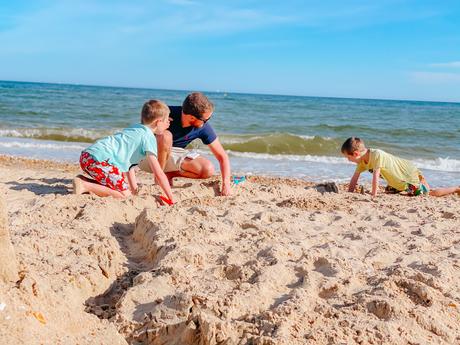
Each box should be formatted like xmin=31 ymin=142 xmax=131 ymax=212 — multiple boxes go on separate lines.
xmin=0 ymin=157 xmax=460 ymax=345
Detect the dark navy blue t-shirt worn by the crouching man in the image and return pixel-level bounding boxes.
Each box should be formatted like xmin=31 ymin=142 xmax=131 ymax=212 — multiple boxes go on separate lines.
xmin=169 ymin=106 xmax=217 ymax=148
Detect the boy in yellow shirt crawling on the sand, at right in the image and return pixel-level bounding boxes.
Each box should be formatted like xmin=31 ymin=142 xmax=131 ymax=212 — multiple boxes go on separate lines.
xmin=342 ymin=137 xmax=460 ymax=197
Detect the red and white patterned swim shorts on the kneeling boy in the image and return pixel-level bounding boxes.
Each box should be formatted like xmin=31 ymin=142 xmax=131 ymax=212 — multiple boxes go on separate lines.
xmin=80 ymin=151 xmax=129 ymax=192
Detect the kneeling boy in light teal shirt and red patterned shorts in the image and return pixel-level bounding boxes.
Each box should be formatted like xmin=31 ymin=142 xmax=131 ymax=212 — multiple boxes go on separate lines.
xmin=73 ymin=100 xmax=173 ymax=203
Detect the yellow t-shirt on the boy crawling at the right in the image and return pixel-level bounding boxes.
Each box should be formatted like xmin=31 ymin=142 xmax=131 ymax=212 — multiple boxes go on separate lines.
xmin=356 ymin=149 xmax=420 ymax=191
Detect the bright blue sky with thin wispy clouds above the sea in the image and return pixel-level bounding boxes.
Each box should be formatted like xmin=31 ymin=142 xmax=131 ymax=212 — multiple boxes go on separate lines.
xmin=0 ymin=0 xmax=460 ymax=102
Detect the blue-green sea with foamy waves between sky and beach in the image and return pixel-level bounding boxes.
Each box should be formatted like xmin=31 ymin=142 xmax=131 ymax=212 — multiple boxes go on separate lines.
xmin=0 ymin=81 xmax=460 ymax=186
